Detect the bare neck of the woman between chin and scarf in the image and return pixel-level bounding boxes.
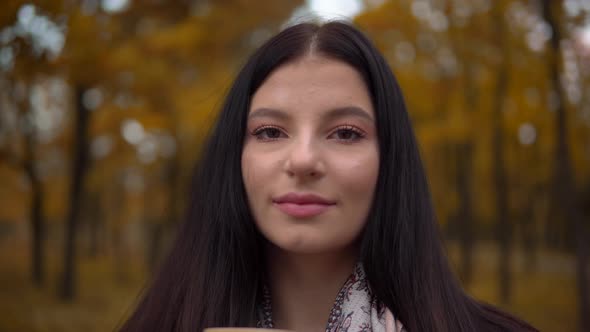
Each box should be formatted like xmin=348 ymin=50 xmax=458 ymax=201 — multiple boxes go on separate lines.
xmin=267 ymin=247 xmax=358 ymax=331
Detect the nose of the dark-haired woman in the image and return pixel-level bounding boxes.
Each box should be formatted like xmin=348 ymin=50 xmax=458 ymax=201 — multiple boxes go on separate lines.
xmin=285 ymin=138 xmax=325 ymax=179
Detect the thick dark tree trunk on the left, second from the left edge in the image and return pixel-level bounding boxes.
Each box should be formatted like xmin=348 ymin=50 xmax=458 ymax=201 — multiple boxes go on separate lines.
xmin=59 ymin=86 xmax=90 ymax=301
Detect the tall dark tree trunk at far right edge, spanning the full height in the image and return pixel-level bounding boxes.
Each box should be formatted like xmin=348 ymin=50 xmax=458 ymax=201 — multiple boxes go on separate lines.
xmin=541 ymin=0 xmax=590 ymax=331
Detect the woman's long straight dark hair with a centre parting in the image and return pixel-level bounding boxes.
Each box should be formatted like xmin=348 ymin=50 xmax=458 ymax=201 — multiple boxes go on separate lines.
xmin=121 ymin=22 xmax=534 ymax=332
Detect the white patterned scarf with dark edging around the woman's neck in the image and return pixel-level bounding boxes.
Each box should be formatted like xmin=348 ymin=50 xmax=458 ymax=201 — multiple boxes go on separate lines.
xmin=257 ymin=263 xmax=405 ymax=332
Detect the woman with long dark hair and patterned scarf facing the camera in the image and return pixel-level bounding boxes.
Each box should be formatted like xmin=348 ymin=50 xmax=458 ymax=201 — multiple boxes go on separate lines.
xmin=122 ymin=22 xmax=535 ymax=332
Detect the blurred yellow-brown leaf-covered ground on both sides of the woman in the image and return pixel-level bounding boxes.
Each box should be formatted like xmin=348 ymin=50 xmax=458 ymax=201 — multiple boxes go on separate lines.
xmin=0 ymin=239 xmax=577 ymax=332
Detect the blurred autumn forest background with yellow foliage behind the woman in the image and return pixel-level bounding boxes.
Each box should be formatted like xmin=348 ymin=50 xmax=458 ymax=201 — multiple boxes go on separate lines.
xmin=0 ymin=0 xmax=590 ymax=332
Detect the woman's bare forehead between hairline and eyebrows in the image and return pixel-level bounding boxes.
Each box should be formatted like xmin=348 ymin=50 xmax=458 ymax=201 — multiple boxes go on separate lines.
xmin=250 ymin=55 xmax=373 ymax=114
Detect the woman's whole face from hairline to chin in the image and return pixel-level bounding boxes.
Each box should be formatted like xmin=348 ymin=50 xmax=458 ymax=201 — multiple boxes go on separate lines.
xmin=242 ymin=55 xmax=379 ymax=253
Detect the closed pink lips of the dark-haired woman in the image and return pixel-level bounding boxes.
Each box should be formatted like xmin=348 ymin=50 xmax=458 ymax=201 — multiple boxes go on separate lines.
xmin=273 ymin=193 xmax=336 ymax=218
